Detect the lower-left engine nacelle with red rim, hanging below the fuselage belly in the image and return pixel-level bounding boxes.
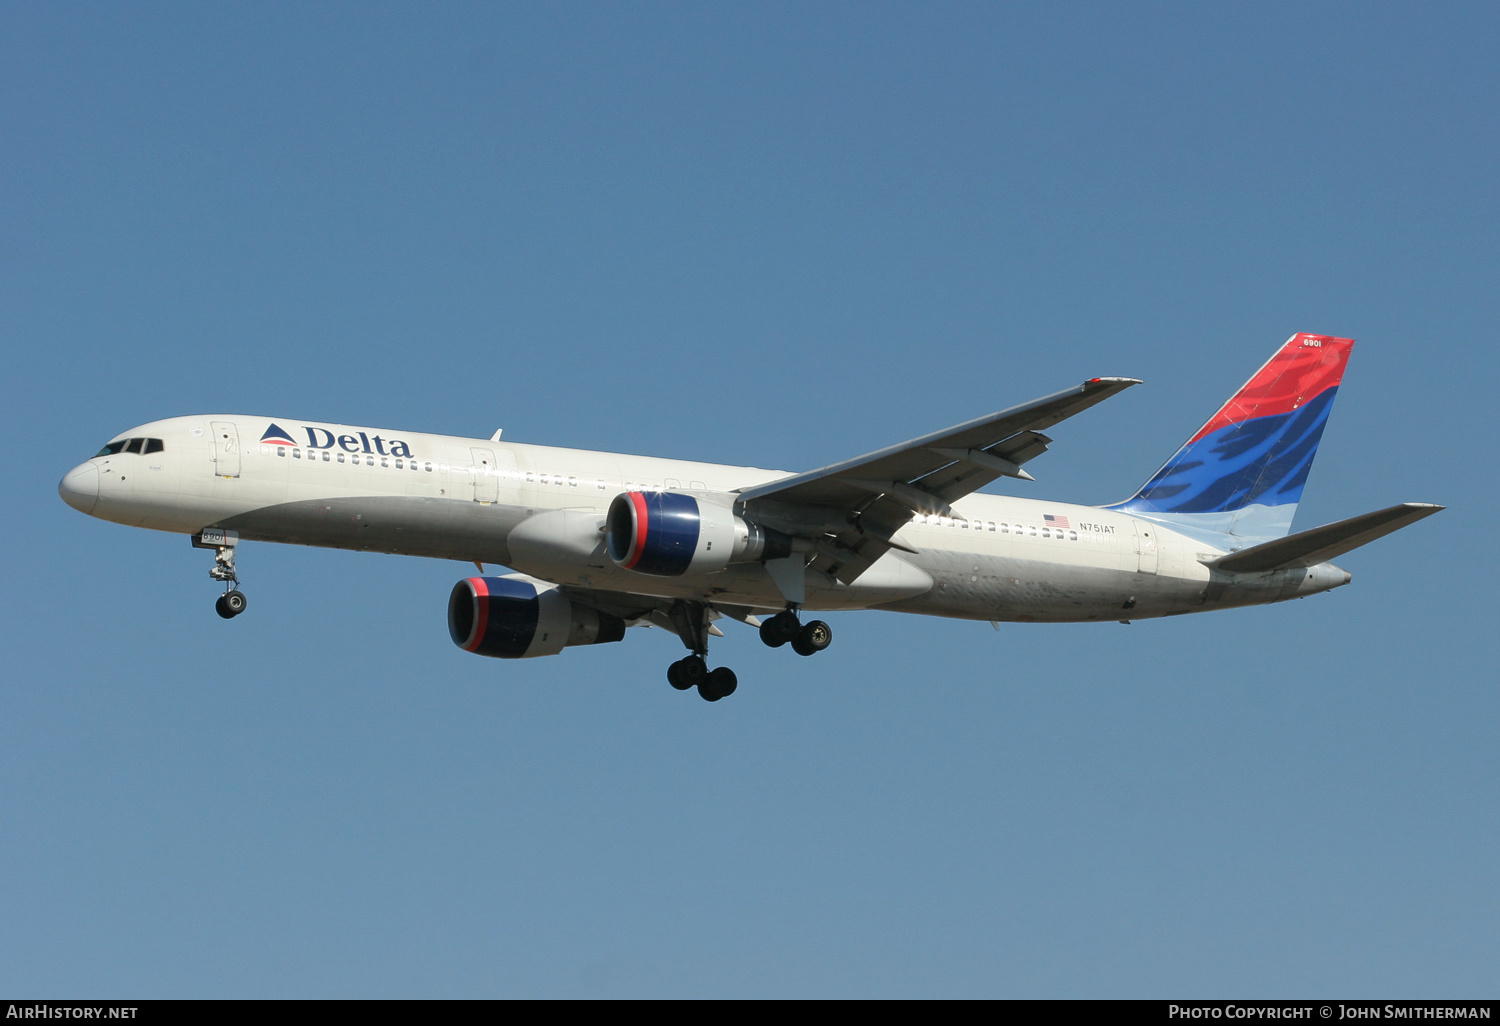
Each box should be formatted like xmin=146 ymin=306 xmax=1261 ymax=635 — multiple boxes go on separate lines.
xmin=449 ymin=575 xmax=626 ymax=659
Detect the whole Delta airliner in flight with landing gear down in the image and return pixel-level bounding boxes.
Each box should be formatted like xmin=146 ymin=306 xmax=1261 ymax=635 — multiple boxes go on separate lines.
xmin=59 ymin=333 xmax=1443 ymax=702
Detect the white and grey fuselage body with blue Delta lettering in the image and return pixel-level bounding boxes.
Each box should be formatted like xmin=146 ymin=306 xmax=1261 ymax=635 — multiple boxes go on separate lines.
xmin=63 ymin=416 xmax=1349 ymax=623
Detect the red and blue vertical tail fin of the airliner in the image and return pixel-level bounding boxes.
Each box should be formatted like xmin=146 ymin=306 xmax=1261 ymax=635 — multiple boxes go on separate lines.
xmin=1110 ymin=335 xmax=1355 ymax=548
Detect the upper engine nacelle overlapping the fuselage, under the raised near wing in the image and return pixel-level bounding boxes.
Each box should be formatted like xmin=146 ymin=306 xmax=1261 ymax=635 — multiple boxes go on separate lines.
xmin=605 ymin=492 xmax=792 ymax=578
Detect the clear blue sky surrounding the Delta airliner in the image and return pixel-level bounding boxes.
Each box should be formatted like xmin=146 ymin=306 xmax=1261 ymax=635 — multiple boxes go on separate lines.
xmin=0 ymin=3 xmax=1500 ymax=998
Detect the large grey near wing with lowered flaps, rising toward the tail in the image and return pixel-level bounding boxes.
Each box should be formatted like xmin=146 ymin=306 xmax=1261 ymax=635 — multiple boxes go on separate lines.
xmin=738 ymin=378 xmax=1140 ymax=582
